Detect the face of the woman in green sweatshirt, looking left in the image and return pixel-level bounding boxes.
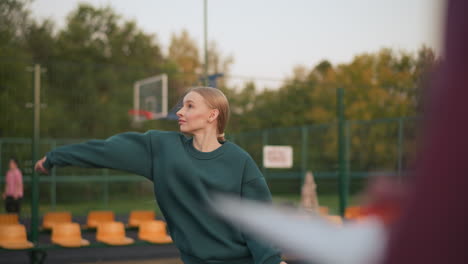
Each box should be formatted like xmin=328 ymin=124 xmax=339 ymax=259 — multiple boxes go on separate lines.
xmin=177 ymin=92 xmax=213 ymax=134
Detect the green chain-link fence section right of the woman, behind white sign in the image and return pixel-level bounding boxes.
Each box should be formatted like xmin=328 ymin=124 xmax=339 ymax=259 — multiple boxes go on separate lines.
xmin=232 ymin=118 xmax=417 ymax=210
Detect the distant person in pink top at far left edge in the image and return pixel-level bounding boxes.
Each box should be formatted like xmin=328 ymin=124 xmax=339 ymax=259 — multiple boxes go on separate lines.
xmin=2 ymin=158 xmax=23 ymax=214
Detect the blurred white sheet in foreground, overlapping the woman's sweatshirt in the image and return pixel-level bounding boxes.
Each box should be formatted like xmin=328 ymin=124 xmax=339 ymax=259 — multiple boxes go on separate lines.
xmin=213 ymin=195 xmax=386 ymax=264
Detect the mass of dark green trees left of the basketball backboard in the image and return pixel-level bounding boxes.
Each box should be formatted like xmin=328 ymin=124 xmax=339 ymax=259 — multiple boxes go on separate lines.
xmin=0 ymin=1 xmax=167 ymax=138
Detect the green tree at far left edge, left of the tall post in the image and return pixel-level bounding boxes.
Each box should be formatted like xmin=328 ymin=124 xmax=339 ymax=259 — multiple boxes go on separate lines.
xmin=0 ymin=0 xmax=32 ymax=137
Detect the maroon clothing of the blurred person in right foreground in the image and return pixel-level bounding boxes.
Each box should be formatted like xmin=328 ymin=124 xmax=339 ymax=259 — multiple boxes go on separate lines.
xmin=382 ymin=0 xmax=468 ymax=264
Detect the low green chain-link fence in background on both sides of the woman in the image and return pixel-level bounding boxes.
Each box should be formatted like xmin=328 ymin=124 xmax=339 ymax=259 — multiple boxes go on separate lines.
xmin=0 ymin=117 xmax=417 ymax=214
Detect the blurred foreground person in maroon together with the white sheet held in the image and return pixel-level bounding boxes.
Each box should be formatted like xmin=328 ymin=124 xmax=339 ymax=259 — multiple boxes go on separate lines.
xmin=215 ymin=0 xmax=468 ymax=264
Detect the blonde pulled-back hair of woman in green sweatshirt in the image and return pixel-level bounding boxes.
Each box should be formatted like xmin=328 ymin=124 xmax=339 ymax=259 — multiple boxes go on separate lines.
xmin=187 ymin=87 xmax=230 ymax=141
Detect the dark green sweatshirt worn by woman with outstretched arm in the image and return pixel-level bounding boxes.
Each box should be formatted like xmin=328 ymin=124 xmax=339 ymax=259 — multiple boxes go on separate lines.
xmin=44 ymin=130 xmax=281 ymax=264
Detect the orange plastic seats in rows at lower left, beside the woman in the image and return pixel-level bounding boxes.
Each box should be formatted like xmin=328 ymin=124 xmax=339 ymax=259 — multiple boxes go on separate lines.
xmin=0 ymin=211 xmax=172 ymax=249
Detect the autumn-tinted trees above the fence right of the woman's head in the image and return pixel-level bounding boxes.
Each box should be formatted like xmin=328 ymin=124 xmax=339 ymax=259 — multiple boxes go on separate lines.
xmin=227 ymin=47 xmax=435 ymax=134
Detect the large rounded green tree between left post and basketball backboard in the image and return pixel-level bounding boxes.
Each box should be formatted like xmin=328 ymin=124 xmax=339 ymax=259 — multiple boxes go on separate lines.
xmin=38 ymin=4 xmax=165 ymax=137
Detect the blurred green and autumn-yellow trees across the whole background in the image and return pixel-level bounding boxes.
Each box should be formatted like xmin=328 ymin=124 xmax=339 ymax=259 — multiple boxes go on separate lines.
xmin=0 ymin=0 xmax=435 ymax=182
